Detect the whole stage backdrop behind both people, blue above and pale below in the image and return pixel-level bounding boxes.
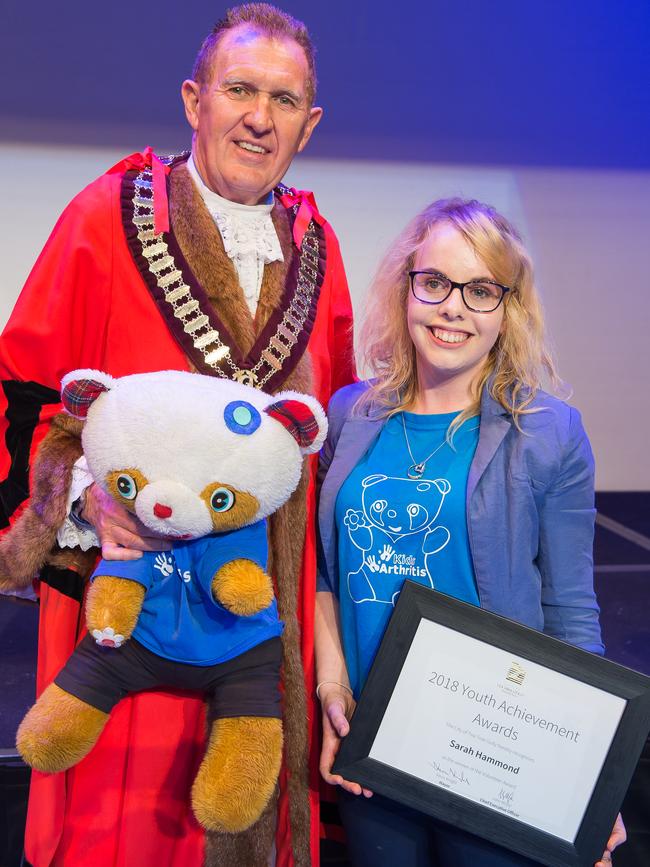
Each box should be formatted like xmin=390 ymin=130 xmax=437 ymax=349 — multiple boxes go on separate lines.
xmin=0 ymin=0 xmax=650 ymax=490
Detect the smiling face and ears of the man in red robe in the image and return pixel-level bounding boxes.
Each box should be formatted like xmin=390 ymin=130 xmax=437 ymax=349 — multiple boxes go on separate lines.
xmin=182 ymin=25 xmax=322 ymax=205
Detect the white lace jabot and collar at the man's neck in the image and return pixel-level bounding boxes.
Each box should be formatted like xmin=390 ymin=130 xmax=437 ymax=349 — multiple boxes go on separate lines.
xmin=187 ymin=155 xmax=284 ymax=316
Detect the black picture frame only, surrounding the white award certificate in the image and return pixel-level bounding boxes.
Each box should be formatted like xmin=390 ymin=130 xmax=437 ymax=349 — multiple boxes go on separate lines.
xmin=333 ymin=581 xmax=650 ymax=867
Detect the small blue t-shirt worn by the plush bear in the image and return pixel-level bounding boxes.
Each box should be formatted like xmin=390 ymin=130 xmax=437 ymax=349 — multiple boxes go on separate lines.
xmin=92 ymin=521 xmax=283 ymax=665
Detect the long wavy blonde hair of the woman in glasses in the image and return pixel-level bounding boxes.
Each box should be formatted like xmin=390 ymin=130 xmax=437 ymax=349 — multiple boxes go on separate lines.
xmin=360 ymin=198 xmax=562 ymax=441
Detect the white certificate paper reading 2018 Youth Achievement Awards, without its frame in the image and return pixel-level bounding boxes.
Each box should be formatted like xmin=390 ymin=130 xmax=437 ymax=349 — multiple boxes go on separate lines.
xmin=369 ymin=619 xmax=627 ymax=842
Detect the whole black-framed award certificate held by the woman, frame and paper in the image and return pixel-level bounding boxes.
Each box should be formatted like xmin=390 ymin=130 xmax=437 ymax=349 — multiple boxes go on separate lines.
xmin=334 ymin=581 xmax=650 ymax=867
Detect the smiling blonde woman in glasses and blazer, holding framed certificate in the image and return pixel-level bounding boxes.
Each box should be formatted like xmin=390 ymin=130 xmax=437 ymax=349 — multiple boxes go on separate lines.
xmin=316 ymin=199 xmax=625 ymax=867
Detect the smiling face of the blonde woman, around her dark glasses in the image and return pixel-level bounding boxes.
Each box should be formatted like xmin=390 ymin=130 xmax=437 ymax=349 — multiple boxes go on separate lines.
xmin=407 ymin=222 xmax=504 ymax=391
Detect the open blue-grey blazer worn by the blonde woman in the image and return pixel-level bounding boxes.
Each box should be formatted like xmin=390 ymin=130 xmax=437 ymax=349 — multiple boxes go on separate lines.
xmin=318 ymin=383 xmax=604 ymax=653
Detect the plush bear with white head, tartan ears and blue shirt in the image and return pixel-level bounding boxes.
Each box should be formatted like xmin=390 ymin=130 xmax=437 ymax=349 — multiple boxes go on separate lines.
xmin=17 ymin=370 xmax=327 ymax=832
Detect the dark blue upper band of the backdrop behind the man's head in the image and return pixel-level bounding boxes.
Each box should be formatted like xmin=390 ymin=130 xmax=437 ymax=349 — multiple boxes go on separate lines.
xmin=0 ymin=0 xmax=650 ymax=168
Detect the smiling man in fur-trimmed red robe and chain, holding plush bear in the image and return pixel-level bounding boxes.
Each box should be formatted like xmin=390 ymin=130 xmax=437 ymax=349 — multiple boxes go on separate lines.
xmin=0 ymin=4 xmax=354 ymax=867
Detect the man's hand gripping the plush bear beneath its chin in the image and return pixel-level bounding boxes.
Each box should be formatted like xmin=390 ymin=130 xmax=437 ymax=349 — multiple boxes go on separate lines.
xmin=82 ymin=484 xmax=172 ymax=560
